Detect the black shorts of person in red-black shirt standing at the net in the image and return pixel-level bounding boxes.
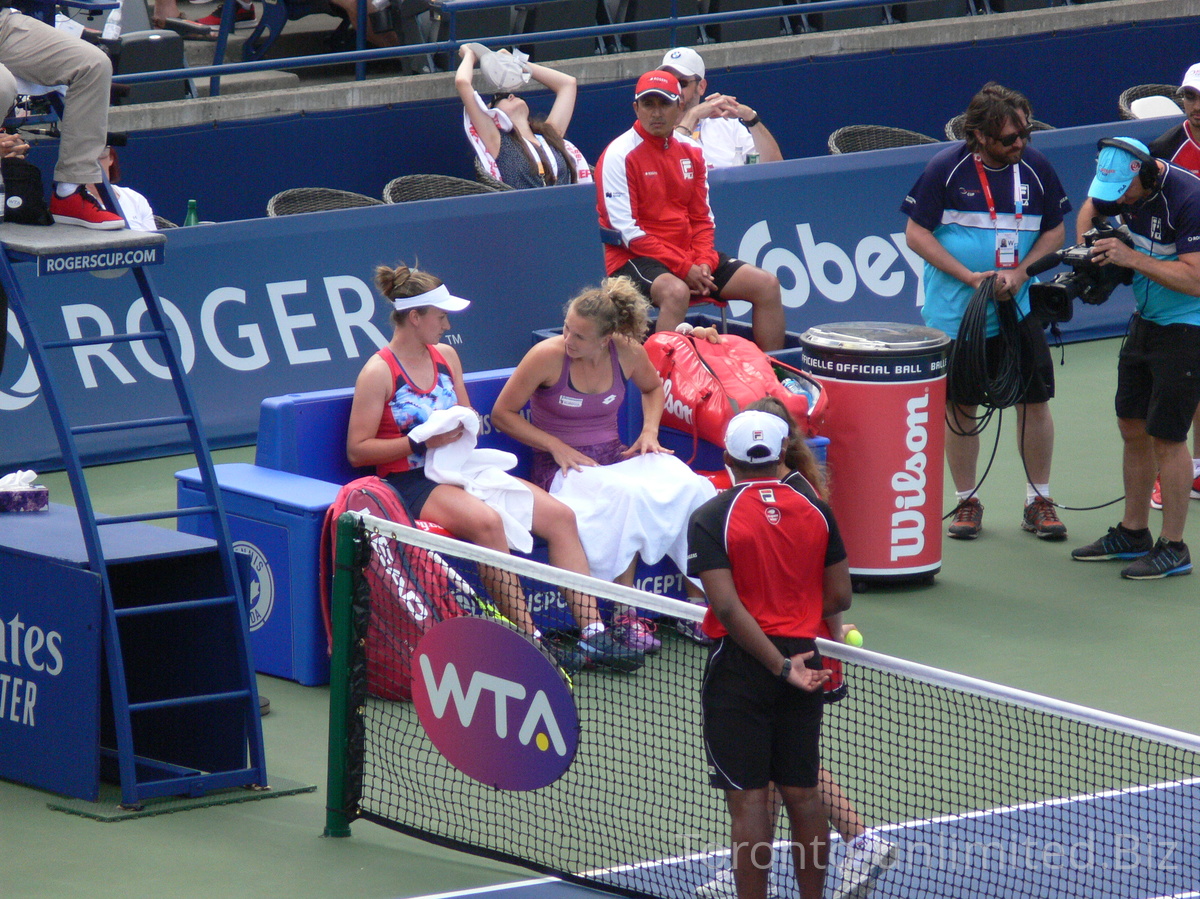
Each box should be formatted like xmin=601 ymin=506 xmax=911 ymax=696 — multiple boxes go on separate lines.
xmin=701 ymin=636 xmax=824 ymax=790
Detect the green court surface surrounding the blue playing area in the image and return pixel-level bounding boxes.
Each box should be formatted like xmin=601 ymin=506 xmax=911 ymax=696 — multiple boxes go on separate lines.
xmin=0 ymin=340 xmax=1200 ymax=899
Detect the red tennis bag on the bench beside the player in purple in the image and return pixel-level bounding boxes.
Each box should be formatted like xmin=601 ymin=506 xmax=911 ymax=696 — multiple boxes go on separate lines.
xmin=646 ymin=331 xmax=826 ymax=446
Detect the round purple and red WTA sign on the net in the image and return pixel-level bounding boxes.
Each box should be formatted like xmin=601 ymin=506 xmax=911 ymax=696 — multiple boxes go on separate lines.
xmin=413 ymin=618 xmax=580 ymax=790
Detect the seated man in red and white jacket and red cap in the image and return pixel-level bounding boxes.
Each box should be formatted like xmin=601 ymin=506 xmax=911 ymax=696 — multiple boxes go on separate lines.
xmin=595 ymin=71 xmax=785 ymax=350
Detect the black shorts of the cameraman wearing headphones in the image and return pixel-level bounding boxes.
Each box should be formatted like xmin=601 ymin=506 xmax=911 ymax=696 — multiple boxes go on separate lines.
xmin=1115 ymin=316 xmax=1200 ymax=443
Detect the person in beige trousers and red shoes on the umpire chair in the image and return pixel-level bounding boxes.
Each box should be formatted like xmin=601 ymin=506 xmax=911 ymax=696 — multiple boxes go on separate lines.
xmin=0 ymin=10 xmax=125 ymax=230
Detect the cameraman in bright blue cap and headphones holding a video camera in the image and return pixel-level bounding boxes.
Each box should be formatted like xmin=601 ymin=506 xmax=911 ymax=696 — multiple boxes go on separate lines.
xmin=1070 ymin=137 xmax=1200 ymax=581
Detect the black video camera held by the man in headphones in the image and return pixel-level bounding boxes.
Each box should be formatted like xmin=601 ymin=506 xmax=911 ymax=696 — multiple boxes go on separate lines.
xmin=1027 ymin=216 xmax=1133 ymax=324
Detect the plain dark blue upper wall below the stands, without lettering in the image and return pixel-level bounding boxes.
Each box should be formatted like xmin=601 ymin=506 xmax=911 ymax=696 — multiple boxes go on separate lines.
xmin=54 ymin=17 xmax=1198 ymax=222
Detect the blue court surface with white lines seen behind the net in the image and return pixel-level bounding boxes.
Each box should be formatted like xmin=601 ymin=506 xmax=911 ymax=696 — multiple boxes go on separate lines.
xmin=405 ymin=779 xmax=1200 ymax=899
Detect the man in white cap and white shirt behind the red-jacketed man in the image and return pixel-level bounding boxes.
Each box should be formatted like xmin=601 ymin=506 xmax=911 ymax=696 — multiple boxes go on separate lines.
xmin=660 ymin=47 xmax=784 ymax=168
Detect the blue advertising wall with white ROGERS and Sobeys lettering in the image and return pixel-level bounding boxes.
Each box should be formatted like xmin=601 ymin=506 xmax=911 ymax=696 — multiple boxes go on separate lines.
xmin=0 ymin=121 xmax=1164 ymax=471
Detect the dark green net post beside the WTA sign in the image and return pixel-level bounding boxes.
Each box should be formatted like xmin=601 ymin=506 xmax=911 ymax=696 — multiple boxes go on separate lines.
xmin=325 ymin=514 xmax=358 ymax=837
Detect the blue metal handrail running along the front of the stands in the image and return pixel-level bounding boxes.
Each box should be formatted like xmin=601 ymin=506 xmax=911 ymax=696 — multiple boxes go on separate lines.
xmin=113 ymin=0 xmax=1003 ymax=90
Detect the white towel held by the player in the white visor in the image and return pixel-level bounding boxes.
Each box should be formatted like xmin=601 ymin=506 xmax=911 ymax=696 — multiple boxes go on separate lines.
xmin=408 ymin=406 xmax=533 ymax=552
